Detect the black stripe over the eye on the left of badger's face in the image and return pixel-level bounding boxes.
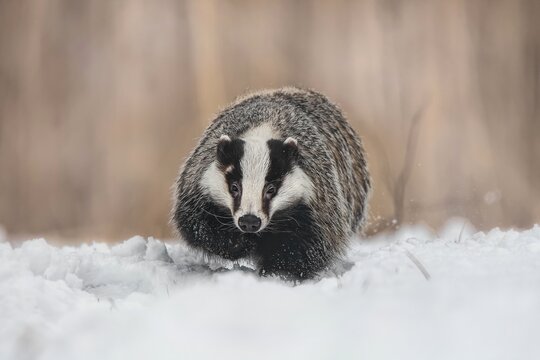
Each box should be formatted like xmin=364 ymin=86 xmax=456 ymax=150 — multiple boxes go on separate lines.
xmin=217 ymin=139 xmax=244 ymax=211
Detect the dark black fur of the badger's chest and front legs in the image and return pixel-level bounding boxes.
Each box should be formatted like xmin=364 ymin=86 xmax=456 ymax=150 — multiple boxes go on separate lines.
xmin=176 ymin=195 xmax=331 ymax=279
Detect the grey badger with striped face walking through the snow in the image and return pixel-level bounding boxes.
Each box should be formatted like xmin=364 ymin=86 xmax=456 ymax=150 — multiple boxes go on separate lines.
xmin=171 ymin=88 xmax=371 ymax=279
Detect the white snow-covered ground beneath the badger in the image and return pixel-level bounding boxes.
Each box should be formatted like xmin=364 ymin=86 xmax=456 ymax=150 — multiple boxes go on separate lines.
xmin=0 ymin=221 xmax=540 ymax=360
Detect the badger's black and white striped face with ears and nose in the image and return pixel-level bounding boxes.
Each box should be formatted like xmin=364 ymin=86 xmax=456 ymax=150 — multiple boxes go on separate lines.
xmin=202 ymin=127 xmax=312 ymax=232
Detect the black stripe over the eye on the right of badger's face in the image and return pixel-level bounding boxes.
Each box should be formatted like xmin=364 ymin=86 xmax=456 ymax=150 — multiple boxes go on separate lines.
xmin=262 ymin=139 xmax=297 ymax=215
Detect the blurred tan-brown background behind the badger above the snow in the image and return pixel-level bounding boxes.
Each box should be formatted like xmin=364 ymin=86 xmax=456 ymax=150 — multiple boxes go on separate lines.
xmin=0 ymin=0 xmax=540 ymax=241
